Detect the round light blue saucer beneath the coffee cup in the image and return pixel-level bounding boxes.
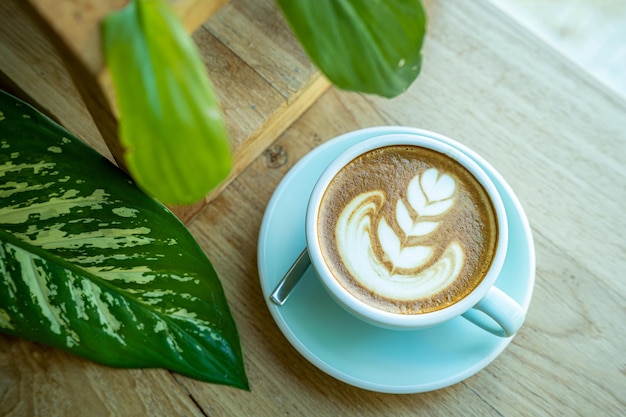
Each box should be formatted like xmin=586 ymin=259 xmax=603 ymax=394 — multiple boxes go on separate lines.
xmin=258 ymin=126 xmax=535 ymax=394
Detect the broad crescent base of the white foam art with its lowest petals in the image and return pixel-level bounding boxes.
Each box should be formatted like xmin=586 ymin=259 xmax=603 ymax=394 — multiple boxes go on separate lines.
xmin=335 ymin=184 xmax=463 ymax=300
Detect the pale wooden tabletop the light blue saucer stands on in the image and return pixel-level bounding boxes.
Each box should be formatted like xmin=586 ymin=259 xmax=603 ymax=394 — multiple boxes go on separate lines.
xmin=0 ymin=0 xmax=626 ymax=417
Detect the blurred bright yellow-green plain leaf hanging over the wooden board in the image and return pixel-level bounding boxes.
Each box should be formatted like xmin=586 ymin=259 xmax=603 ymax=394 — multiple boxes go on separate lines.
xmin=103 ymin=0 xmax=232 ymax=204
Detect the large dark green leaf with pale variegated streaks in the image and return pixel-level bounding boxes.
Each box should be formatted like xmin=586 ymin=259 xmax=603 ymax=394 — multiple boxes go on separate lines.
xmin=0 ymin=91 xmax=247 ymax=388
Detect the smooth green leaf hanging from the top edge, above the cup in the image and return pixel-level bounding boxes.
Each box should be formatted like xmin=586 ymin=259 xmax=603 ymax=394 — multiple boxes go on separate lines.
xmin=277 ymin=0 xmax=426 ymax=97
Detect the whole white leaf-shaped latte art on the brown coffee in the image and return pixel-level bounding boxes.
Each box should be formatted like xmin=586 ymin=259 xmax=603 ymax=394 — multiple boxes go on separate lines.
xmin=336 ymin=169 xmax=464 ymax=301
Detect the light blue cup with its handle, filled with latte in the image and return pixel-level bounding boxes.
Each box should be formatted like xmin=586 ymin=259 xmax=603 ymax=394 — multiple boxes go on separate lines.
xmin=306 ymin=134 xmax=524 ymax=337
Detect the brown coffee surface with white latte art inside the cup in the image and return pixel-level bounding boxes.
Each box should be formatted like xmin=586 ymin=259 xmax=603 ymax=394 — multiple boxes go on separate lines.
xmin=317 ymin=145 xmax=498 ymax=314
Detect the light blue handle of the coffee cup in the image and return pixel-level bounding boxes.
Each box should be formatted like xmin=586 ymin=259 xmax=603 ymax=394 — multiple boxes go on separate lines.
xmin=462 ymin=286 xmax=526 ymax=337
